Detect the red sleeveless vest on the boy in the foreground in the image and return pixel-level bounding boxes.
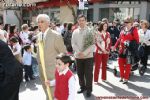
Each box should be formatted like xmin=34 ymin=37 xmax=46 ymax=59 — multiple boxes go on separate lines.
xmin=54 ymin=70 xmax=73 ymax=100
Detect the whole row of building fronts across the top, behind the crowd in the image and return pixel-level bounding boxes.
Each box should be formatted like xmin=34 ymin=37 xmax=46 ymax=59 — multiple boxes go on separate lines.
xmin=0 ymin=0 xmax=150 ymax=26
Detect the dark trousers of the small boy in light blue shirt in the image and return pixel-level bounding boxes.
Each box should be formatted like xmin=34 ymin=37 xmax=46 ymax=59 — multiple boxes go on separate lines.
xmin=24 ymin=65 xmax=33 ymax=81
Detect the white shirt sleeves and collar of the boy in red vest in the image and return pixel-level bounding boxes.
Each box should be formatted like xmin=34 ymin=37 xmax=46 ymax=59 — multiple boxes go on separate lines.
xmin=50 ymin=68 xmax=77 ymax=100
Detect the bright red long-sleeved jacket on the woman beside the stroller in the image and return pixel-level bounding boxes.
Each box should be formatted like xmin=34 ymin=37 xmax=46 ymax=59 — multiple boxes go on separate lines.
xmin=115 ymin=27 xmax=139 ymax=54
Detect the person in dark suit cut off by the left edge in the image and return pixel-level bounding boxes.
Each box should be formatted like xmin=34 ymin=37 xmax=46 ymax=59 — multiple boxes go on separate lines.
xmin=0 ymin=40 xmax=23 ymax=100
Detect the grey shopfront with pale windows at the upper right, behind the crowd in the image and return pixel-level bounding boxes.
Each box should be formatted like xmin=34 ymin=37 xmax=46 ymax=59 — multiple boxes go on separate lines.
xmin=87 ymin=1 xmax=150 ymax=22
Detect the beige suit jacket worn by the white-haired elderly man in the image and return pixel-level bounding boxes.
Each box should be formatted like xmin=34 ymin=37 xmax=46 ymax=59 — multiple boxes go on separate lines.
xmin=37 ymin=29 xmax=66 ymax=97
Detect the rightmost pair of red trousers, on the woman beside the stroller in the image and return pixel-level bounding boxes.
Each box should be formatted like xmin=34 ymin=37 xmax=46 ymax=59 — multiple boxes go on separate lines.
xmin=118 ymin=57 xmax=131 ymax=80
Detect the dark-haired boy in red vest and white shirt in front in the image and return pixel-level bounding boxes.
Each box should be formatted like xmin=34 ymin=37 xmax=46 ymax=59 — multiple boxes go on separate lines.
xmin=45 ymin=54 xmax=76 ymax=100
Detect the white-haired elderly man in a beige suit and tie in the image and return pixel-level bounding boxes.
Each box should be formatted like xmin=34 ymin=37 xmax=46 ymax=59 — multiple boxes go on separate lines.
xmin=37 ymin=14 xmax=66 ymax=100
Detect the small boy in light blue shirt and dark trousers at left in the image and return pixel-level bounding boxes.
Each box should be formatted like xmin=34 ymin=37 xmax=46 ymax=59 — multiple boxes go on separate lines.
xmin=23 ymin=45 xmax=34 ymax=81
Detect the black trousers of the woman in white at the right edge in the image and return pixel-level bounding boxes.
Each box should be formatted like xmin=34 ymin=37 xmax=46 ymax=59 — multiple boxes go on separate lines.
xmin=141 ymin=46 xmax=150 ymax=67
